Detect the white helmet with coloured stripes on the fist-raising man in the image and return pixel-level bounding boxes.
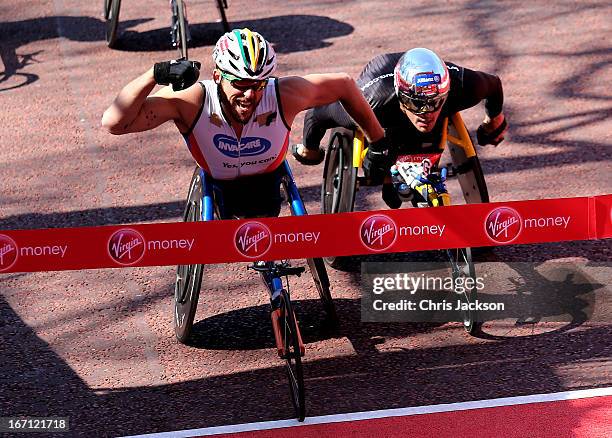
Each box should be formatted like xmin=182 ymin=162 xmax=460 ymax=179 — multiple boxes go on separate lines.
xmin=213 ymin=28 xmax=276 ymax=80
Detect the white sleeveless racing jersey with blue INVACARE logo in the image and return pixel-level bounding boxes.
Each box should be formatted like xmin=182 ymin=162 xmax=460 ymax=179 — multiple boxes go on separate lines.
xmin=183 ymin=78 xmax=290 ymax=180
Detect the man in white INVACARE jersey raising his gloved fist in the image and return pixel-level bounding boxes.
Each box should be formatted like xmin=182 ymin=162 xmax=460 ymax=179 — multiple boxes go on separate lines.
xmin=102 ymin=28 xmax=385 ymax=219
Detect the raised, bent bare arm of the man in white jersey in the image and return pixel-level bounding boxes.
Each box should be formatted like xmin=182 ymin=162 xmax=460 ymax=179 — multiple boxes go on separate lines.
xmin=102 ymin=68 xmax=197 ymax=135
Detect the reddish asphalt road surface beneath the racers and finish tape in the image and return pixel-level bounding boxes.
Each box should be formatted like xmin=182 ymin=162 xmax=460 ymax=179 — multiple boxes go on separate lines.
xmin=0 ymin=0 xmax=612 ymax=436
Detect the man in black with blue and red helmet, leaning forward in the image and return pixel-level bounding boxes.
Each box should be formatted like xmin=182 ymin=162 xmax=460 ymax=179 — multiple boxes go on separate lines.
xmin=292 ymin=48 xmax=507 ymax=208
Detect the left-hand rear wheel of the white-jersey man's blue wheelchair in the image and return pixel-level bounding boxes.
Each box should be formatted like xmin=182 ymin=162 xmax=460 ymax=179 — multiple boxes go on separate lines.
xmin=173 ymin=168 xmax=204 ymax=344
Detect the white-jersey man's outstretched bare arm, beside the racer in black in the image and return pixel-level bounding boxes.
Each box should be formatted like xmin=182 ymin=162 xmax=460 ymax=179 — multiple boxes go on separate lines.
xmin=279 ymin=73 xmax=384 ymax=142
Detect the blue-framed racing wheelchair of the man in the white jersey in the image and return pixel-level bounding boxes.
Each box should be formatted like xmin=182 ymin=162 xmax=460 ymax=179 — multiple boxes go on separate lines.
xmin=173 ymin=161 xmax=338 ymax=421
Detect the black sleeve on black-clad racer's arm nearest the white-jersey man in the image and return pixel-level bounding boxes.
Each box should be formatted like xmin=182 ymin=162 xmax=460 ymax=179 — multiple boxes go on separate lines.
xmin=302 ymin=102 xmax=356 ymax=151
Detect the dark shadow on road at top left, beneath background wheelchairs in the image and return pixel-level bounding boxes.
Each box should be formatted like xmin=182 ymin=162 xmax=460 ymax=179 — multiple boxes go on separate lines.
xmin=0 ymin=15 xmax=353 ymax=91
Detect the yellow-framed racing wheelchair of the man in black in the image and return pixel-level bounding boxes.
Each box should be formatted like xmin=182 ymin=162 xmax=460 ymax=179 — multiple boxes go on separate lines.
xmin=321 ymin=113 xmax=489 ymax=334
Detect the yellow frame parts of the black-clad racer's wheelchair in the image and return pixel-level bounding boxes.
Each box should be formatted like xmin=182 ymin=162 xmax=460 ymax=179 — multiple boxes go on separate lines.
xmin=353 ymin=113 xmax=476 ymax=207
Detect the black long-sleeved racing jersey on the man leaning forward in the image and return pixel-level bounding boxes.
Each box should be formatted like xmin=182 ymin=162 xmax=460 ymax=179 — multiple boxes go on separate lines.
xmin=304 ymin=52 xmax=504 ymax=153
